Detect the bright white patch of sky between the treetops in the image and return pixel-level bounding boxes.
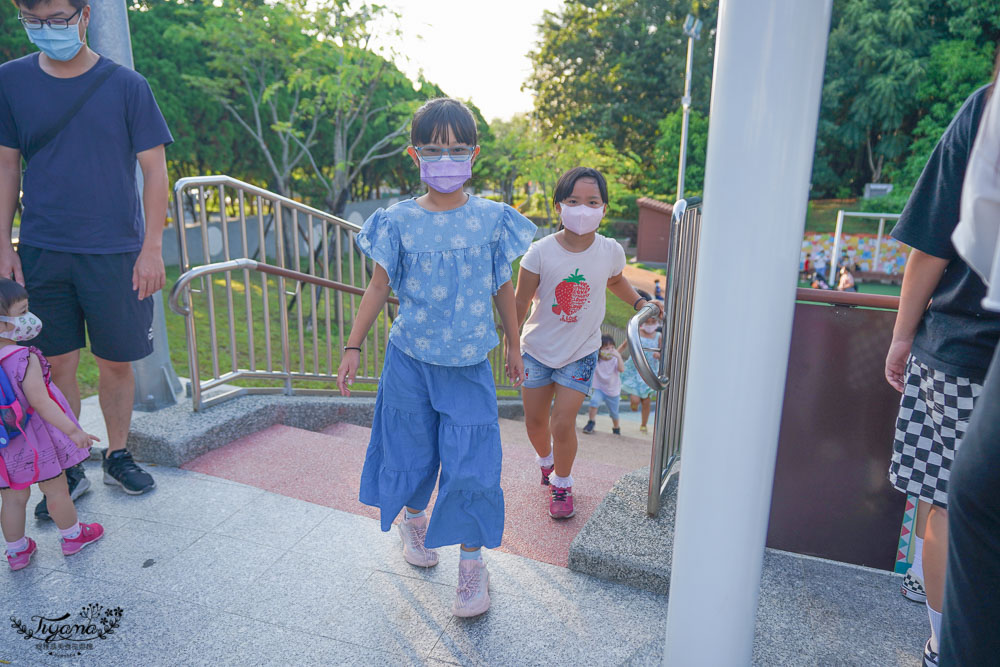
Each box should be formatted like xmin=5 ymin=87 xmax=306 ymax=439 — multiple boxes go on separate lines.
xmin=381 ymin=0 xmax=561 ymax=121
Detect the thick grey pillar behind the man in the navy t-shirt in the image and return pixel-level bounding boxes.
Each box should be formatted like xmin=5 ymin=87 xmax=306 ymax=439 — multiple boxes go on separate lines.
xmin=87 ymin=0 xmax=181 ymax=412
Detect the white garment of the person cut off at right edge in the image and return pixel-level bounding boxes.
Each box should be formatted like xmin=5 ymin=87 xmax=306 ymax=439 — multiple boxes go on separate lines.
xmin=951 ymin=82 xmax=1000 ymax=311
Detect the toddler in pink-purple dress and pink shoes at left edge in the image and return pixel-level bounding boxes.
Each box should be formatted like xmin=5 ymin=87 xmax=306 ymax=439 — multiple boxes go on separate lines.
xmin=0 ymin=278 xmax=104 ymax=570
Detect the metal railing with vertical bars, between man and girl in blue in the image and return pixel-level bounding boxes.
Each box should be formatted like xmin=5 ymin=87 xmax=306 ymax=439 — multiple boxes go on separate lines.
xmin=170 ymin=175 xmax=510 ymax=410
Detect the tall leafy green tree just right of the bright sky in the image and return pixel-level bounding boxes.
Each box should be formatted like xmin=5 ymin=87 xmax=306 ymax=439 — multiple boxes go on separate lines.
xmin=527 ymin=0 xmax=717 ymax=167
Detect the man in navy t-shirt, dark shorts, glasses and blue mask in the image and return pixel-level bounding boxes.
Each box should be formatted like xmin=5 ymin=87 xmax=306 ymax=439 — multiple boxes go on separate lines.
xmin=0 ymin=0 xmax=172 ymax=517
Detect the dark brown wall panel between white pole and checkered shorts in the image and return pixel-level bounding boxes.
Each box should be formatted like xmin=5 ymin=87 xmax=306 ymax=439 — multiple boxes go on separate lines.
xmin=767 ymin=302 xmax=905 ymax=570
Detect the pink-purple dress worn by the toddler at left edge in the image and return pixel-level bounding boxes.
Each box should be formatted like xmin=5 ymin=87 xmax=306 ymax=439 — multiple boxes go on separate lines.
xmin=0 ymin=347 xmax=90 ymax=488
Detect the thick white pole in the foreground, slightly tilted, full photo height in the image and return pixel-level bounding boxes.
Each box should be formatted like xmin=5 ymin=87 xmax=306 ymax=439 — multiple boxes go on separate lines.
xmin=664 ymin=0 xmax=832 ymax=667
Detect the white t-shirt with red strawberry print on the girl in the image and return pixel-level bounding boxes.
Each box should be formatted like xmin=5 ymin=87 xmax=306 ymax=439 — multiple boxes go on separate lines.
xmin=521 ymin=234 xmax=625 ymax=368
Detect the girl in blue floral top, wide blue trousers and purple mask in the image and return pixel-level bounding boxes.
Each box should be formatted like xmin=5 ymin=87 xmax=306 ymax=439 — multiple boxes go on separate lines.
xmin=338 ymin=98 xmax=535 ymax=616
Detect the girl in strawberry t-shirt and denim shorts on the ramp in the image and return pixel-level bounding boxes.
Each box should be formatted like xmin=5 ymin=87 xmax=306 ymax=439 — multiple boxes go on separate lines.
xmin=515 ymin=167 xmax=646 ymax=519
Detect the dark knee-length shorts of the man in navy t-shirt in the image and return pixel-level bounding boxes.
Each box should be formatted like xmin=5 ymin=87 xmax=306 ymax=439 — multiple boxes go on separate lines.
xmin=17 ymin=245 xmax=153 ymax=361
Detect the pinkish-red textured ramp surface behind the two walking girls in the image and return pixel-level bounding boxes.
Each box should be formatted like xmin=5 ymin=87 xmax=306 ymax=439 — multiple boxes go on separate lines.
xmin=183 ymin=412 xmax=651 ymax=567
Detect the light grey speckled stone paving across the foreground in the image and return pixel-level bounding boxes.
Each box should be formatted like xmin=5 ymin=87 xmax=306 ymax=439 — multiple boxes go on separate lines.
xmin=0 ymin=396 xmax=926 ymax=667
